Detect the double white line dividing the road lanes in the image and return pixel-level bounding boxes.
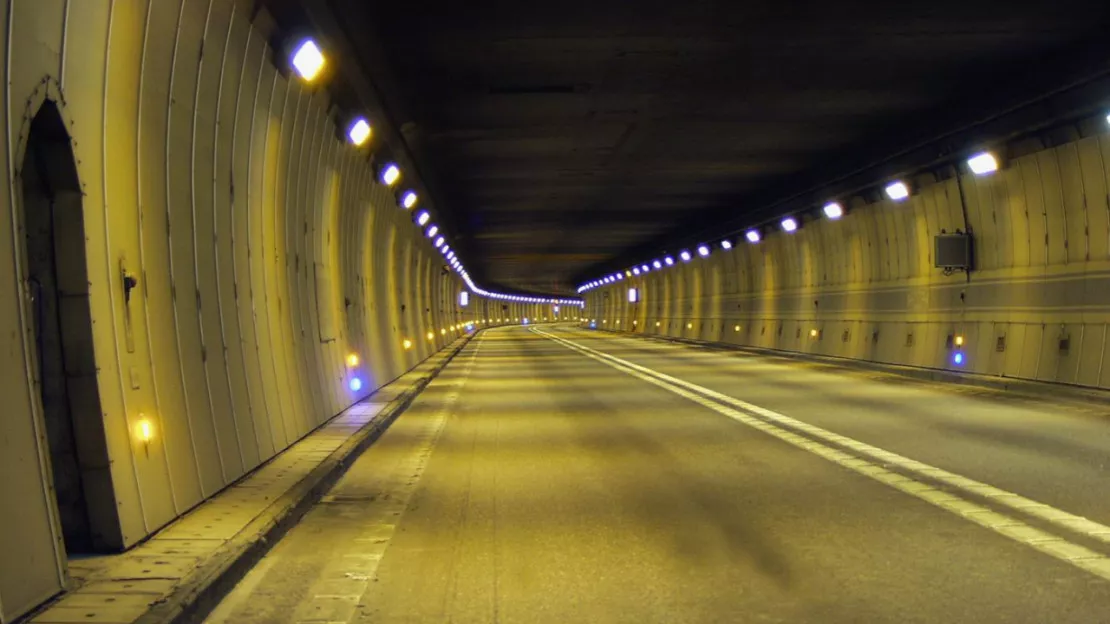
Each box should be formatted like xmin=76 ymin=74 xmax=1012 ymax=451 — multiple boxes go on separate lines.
xmin=531 ymin=329 xmax=1110 ymax=581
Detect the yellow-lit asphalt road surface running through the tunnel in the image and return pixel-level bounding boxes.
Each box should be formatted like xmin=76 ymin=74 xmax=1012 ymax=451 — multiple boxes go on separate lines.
xmin=210 ymin=326 xmax=1110 ymax=623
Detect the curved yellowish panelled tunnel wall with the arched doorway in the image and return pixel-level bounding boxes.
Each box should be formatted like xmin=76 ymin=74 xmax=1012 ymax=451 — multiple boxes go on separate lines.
xmin=0 ymin=0 xmax=572 ymax=622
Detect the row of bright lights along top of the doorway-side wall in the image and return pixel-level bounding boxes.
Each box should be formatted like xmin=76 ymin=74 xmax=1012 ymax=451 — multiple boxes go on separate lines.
xmin=291 ymin=39 xmax=585 ymax=306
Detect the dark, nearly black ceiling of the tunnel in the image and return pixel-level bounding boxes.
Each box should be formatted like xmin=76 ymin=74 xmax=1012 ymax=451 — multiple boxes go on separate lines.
xmin=332 ymin=0 xmax=1110 ymax=293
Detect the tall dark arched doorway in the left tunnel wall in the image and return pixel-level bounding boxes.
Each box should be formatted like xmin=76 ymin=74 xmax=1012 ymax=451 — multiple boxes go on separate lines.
xmin=20 ymin=100 xmax=114 ymax=554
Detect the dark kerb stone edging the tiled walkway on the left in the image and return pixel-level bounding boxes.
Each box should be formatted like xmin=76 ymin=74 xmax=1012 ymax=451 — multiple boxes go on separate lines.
xmin=135 ymin=332 xmax=477 ymax=624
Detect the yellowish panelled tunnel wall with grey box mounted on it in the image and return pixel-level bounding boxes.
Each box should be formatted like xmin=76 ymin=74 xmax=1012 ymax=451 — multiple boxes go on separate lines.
xmin=586 ymin=128 xmax=1110 ymax=388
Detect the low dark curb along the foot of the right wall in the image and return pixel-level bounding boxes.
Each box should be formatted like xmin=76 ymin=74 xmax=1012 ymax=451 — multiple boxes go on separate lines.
xmin=592 ymin=329 xmax=1110 ymax=404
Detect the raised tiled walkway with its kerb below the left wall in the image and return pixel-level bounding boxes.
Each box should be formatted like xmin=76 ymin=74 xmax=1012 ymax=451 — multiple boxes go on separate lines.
xmin=30 ymin=336 xmax=471 ymax=624
